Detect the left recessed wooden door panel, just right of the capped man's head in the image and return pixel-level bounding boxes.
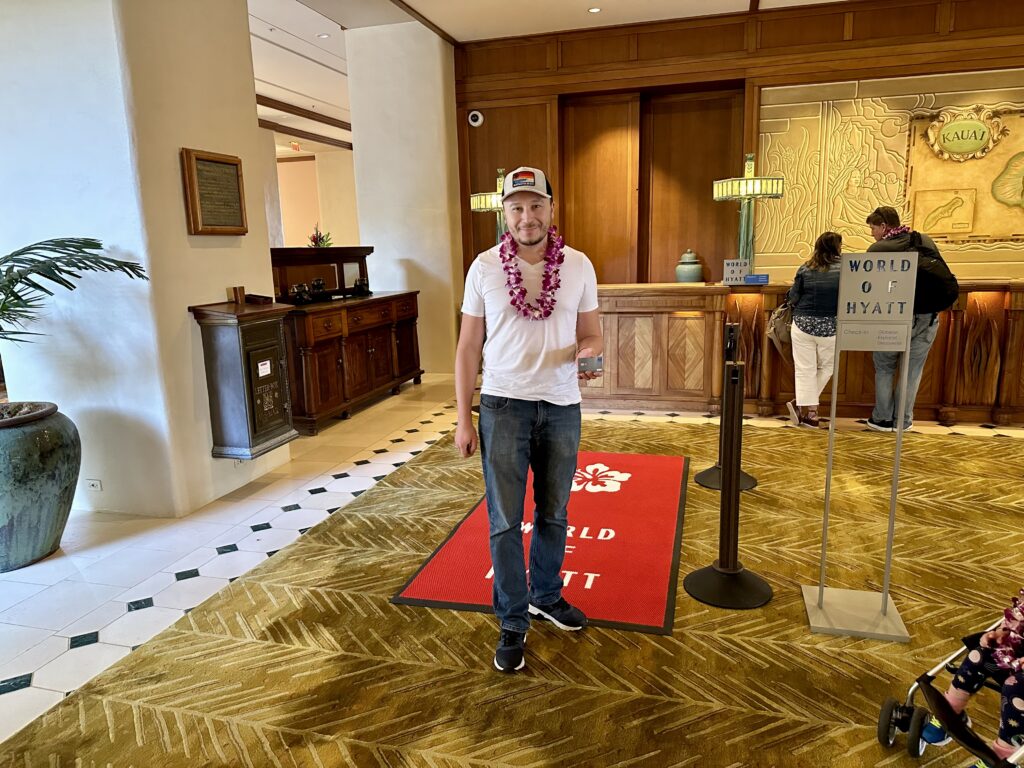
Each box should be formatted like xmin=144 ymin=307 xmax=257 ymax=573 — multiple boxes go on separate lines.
xmin=555 ymin=93 xmax=640 ymax=283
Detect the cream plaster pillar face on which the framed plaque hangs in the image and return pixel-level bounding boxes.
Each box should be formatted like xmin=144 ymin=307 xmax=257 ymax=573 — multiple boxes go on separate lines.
xmin=118 ymin=0 xmax=290 ymax=515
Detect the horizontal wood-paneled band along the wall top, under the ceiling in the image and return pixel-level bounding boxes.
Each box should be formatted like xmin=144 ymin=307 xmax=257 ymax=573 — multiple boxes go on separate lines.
xmin=456 ymin=0 xmax=1024 ymax=102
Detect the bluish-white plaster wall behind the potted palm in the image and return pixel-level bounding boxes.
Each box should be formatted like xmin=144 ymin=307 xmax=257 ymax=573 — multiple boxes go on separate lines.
xmin=0 ymin=0 xmax=183 ymax=514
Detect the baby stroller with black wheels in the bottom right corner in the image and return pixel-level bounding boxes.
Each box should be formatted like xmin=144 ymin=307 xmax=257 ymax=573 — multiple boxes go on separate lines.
xmin=878 ymin=616 xmax=1024 ymax=768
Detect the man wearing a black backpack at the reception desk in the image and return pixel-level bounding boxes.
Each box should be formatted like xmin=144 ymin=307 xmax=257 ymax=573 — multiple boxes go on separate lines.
xmin=866 ymin=206 xmax=959 ymax=432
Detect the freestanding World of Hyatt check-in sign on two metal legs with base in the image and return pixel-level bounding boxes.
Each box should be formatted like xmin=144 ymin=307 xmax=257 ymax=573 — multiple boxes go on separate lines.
xmin=802 ymin=251 xmax=918 ymax=642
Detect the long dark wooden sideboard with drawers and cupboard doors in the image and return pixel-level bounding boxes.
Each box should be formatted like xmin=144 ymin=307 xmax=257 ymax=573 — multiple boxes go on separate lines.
xmin=285 ymin=291 xmax=423 ymax=434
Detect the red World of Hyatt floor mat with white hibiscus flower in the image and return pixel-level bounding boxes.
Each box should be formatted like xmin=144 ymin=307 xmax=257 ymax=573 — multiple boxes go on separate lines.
xmin=391 ymin=453 xmax=688 ymax=635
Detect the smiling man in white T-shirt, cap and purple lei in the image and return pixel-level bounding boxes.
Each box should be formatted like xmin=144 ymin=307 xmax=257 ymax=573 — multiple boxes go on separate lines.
xmin=455 ymin=167 xmax=602 ymax=672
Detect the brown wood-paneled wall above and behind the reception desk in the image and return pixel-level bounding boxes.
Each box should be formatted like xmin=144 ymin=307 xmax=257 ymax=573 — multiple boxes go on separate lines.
xmin=456 ymin=0 xmax=1024 ymax=283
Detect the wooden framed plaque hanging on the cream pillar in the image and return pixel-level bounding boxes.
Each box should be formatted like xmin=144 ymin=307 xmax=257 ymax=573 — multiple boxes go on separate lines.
xmin=181 ymin=148 xmax=249 ymax=234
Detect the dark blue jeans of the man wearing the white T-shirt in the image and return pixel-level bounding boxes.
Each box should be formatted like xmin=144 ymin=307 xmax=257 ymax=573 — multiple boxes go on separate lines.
xmin=480 ymin=394 xmax=580 ymax=632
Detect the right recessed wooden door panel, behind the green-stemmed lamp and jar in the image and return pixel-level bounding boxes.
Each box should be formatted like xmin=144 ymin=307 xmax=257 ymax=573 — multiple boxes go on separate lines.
xmin=639 ymin=91 xmax=743 ymax=283
